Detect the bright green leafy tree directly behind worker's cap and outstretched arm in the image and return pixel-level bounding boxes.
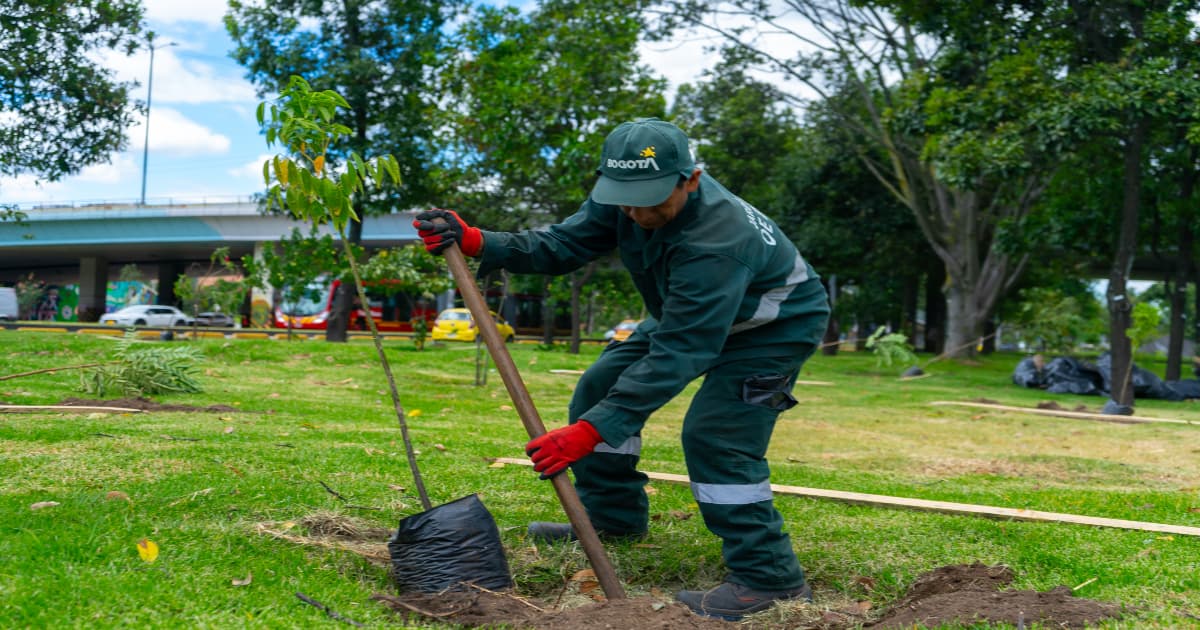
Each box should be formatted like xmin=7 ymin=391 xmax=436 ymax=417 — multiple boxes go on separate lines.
xmin=448 ymin=0 xmax=665 ymax=352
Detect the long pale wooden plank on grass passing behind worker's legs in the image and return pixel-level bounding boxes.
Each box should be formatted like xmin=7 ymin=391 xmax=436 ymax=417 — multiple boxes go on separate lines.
xmin=496 ymin=457 xmax=1200 ymax=536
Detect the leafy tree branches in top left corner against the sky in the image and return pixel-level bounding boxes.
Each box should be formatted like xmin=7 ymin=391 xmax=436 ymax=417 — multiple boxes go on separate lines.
xmin=0 ymin=0 xmax=143 ymax=181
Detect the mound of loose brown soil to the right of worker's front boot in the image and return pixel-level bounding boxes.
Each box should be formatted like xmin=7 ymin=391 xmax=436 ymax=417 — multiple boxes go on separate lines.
xmin=870 ymin=563 xmax=1122 ymax=628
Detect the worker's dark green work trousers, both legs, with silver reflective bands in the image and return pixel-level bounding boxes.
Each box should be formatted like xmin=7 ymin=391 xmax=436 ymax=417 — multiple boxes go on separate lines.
xmin=570 ymin=332 xmax=814 ymax=590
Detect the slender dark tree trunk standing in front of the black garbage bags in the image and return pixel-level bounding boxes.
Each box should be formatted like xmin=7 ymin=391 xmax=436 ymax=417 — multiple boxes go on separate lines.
xmin=1108 ymin=120 xmax=1150 ymax=409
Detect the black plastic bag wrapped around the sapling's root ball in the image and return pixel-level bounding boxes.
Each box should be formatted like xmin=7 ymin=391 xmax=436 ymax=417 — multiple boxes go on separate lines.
xmin=388 ymin=494 xmax=512 ymax=593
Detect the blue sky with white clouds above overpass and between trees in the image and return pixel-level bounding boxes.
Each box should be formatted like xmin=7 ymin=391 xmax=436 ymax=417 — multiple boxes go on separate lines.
xmin=0 ymin=0 xmax=713 ymax=206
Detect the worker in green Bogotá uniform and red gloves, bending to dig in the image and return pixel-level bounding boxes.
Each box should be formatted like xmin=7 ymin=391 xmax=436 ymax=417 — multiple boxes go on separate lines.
xmin=414 ymin=119 xmax=829 ymax=619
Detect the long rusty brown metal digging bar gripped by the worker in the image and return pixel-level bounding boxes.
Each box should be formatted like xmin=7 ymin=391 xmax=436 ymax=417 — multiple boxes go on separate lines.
xmin=442 ymin=237 xmax=625 ymax=600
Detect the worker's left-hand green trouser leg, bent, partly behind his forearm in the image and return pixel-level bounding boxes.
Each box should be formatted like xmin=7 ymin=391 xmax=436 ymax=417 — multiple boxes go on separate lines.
xmin=569 ymin=332 xmax=650 ymax=535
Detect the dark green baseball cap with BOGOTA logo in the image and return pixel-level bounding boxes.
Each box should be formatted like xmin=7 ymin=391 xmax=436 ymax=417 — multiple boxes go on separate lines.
xmin=592 ymin=118 xmax=696 ymax=208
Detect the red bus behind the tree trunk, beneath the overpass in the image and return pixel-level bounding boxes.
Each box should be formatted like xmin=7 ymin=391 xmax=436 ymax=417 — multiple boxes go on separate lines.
xmin=271 ymin=280 xmax=438 ymax=332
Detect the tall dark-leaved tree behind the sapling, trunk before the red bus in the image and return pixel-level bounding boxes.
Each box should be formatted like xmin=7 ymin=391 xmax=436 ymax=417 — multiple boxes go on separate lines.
xmin=226 ymin=0 xmax=461 ymax=341
